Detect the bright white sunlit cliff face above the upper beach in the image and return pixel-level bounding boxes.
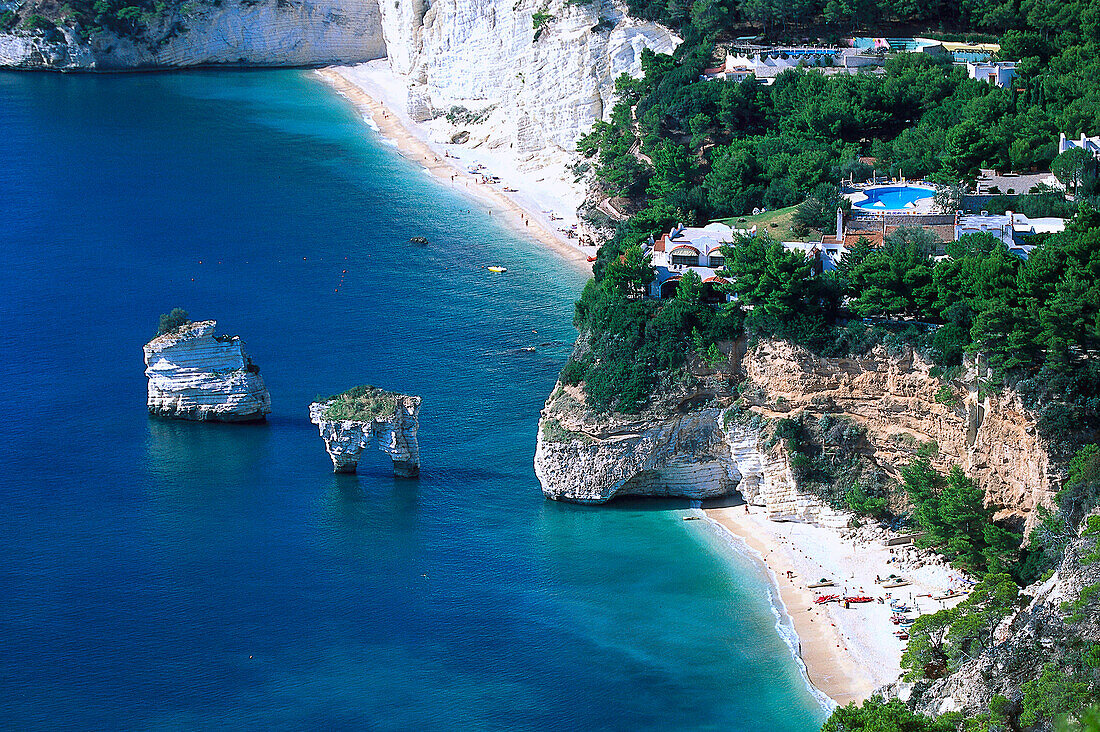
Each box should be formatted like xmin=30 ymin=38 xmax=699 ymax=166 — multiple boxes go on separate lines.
xmin=382 ymin=0 xmax=680 ymax=159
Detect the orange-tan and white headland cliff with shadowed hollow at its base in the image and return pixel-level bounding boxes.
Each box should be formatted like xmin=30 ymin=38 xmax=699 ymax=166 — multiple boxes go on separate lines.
xmin=535 ymin=341 xmax=1058 ymax=524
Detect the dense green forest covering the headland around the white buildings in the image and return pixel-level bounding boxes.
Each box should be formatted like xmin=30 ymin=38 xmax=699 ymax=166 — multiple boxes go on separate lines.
xmin=562 ymin=0 xmax=1100 ymax=732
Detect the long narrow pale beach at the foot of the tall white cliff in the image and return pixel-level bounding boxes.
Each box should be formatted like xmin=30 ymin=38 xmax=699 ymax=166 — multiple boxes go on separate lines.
xmin=317 ymin=64 xmax=596 ymax=271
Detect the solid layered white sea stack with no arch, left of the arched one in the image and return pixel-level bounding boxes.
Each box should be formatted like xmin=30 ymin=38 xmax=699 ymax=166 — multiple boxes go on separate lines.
xmin=144 ymin=320 xmax=272 ymax=422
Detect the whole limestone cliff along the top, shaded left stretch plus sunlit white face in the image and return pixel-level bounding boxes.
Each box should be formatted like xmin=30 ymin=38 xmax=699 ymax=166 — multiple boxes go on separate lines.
xmin=0 ymin=0 xmax=679 ymax=167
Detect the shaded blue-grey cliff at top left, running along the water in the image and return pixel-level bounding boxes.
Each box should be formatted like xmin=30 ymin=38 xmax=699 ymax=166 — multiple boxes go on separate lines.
xmin=0 ymin=0 xmax=386 ymax=70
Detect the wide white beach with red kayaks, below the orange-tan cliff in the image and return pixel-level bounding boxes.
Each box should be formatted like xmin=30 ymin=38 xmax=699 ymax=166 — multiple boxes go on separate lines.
xmin=705 ymin=505 xmax=964 ymax=706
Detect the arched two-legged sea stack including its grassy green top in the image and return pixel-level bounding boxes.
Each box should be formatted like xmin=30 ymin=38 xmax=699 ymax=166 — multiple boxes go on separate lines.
xmin=309 ymin=386 xmax=420 ymax=478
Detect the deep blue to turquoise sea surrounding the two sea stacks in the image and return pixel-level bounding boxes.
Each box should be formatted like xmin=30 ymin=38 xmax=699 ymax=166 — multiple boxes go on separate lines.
xmin=0 ymin=72 xmax=822 ymax=732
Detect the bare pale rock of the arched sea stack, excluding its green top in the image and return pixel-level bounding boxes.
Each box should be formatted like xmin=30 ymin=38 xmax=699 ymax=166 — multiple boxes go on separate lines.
xmin=309 ymin=394 xmax=420 ymax=478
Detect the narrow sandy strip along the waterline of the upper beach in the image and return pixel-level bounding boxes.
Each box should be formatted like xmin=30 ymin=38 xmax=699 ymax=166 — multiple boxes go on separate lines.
xmin=315 ymin=65 xmax=597 ymax=271
